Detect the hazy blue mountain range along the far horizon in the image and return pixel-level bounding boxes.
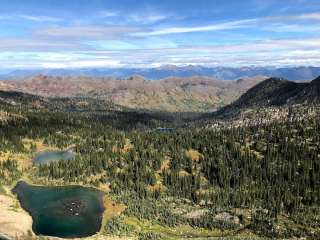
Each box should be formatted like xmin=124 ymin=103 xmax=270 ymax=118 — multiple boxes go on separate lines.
xmin=0 ymin=65 xmax=320 ymax=81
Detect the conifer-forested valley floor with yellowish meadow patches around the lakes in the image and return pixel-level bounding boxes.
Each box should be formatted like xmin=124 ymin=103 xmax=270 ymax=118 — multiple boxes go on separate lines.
xmin=0 ymin=87 xmax=320 ymax=239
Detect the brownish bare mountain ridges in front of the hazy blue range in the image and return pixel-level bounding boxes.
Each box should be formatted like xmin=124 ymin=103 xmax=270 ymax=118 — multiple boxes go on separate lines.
xmin=0 ymin=75 xmax=266 ymax=112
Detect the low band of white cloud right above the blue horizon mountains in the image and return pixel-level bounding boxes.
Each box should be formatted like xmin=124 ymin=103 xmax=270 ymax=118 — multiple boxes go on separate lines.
xmin=0 ymin=38 xmax=320 ymax=68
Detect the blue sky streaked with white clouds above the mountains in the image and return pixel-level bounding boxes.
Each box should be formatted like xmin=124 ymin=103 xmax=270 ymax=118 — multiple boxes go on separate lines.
xmin=0 ymin=0 xmax=320 ymax=71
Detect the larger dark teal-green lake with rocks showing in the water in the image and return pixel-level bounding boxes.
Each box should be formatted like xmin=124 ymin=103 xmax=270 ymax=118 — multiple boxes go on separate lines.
xmin=12 ymin=181 xmax=104 ymax=238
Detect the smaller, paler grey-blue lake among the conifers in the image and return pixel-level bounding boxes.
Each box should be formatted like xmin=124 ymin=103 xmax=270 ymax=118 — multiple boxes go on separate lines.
xmin=33 ymin=150 xmax=76 ymax=164
